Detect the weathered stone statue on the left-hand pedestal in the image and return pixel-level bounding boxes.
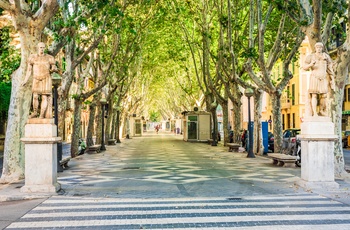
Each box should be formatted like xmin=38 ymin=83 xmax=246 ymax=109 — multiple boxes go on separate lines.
xmin=22 ymin=42 xmax=57 ymax=118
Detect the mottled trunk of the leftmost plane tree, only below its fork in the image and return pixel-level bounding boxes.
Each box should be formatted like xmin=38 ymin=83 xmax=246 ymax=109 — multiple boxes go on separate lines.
xmin=1 ymin=33 xmax=40 ymax=183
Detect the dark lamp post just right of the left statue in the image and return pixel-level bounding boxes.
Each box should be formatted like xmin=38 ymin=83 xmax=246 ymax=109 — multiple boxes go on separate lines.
xmin=52 ymin=73 xmax=63 ymax=172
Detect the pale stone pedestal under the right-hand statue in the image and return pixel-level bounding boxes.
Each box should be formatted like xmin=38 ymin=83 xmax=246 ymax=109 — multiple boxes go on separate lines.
xmin=298 ymin=117 xmax=339 ymax=189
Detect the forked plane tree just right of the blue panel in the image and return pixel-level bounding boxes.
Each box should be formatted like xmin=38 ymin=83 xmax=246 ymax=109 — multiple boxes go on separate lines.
xmin=238 ymin=1 xmax=304 ymax=152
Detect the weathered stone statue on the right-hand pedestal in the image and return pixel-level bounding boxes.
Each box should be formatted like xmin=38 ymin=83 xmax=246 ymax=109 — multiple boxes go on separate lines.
xmin=303 ymin=42 xmax=335 ymax=116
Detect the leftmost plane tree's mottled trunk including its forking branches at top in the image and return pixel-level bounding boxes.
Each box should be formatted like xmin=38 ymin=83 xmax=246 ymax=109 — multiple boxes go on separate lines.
xmin=0 ymin=0 xmax=58 ymax=183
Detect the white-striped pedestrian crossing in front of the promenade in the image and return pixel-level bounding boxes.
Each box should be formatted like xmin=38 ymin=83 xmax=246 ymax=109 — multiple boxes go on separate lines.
xmin=7 ymin=194 xmax=350 ymax=230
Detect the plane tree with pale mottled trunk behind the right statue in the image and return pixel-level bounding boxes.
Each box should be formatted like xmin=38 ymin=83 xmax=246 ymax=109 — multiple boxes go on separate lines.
xmin=275 ymin=0 xmax=350 ymax=177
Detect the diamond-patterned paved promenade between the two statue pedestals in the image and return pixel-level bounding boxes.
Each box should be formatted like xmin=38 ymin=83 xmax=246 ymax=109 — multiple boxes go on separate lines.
xmin=0 ymin=133 xmax=350 ymax=204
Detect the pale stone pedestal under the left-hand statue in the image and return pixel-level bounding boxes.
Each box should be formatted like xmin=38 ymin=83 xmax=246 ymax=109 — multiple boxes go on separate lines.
xmin=21 ymin=118 xmax=61 ymax=193
